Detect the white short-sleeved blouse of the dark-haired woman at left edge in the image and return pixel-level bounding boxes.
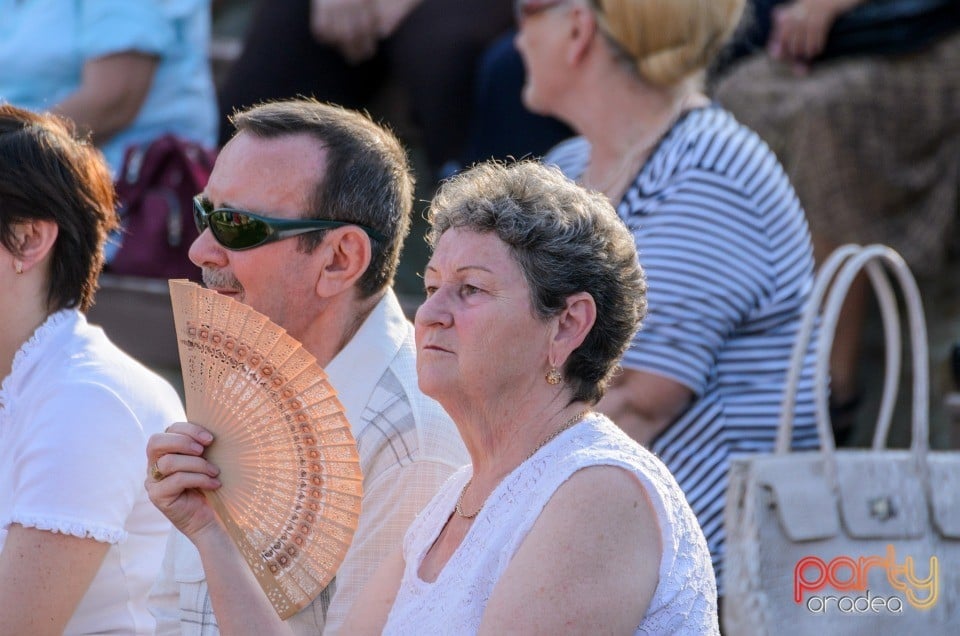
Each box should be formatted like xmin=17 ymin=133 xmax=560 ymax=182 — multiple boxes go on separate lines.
xmin=0 ymin=309 xmax=186 ymax=635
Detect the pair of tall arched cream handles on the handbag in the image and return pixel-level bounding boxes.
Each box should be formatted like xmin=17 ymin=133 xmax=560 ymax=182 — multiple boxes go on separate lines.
xmin=775 ymin=244 xmax=930 ymax=472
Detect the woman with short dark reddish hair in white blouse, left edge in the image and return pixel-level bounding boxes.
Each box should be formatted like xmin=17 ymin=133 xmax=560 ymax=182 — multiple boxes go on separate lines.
xmin=0 ymin=105 xmax=184 ymax=634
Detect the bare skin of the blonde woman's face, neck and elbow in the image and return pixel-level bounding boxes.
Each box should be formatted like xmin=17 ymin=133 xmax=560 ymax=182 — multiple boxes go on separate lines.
xmin=516 ymin=2 xmax=696 ymax=444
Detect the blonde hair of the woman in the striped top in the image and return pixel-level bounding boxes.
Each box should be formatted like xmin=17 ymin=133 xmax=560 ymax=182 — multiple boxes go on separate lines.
xmin=588 ymin=0 xmax=744 ymax=87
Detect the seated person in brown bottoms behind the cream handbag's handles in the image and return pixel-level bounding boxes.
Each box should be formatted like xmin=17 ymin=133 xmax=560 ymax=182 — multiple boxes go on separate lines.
xmin=715 ymin=0 xmax=960 ymax=442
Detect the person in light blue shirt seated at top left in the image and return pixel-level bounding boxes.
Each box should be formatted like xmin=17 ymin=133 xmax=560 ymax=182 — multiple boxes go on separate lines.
xmin=0 ymin=0 xmax=217 ymax=175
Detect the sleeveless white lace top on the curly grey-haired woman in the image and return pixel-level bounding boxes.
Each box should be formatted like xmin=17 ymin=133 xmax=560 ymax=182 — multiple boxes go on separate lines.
xmin=383 ymin=415 xmax=719 ymax=634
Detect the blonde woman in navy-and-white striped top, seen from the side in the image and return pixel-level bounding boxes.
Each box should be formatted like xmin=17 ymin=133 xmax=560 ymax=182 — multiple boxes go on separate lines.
xmin=517 ymin=0 xmax=817 ymax=595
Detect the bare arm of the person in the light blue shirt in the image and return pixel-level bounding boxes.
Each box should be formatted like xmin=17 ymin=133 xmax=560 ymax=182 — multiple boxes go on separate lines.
xmin=52 ymin=51 xmax=159 ymax=144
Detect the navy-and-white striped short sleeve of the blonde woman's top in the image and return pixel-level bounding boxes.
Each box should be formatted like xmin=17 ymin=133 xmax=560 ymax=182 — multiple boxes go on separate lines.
xmin=624 ymin=170 xmax=772 ymax=396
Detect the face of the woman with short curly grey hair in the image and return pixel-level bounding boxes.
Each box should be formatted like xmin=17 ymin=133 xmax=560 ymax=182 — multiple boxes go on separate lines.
xmin=415 ymin=229 xmax=549 ymax=438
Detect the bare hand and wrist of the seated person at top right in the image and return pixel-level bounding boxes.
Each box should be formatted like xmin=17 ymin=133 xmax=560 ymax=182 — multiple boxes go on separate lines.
xmin=767 ymin=0 xmax=866 ymax=72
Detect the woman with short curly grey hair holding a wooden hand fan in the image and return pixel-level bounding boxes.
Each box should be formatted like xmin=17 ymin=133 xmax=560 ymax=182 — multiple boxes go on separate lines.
xmin=149 ymin=163 xmax=717 ymax=634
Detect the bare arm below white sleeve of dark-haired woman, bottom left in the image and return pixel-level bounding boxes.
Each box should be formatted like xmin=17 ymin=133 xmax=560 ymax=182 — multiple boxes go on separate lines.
xmin=0 ymin=523 xmax=110 ymax=636
